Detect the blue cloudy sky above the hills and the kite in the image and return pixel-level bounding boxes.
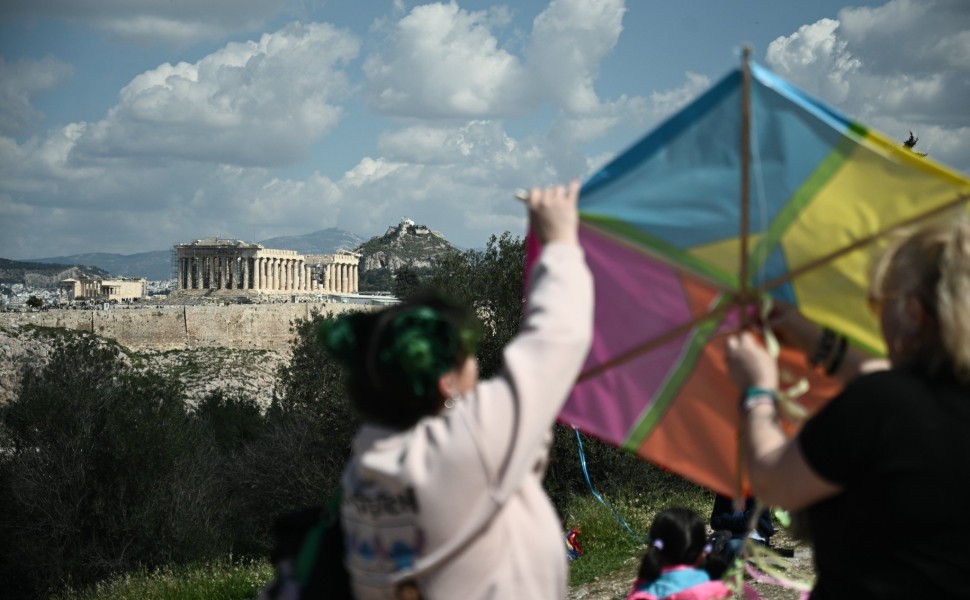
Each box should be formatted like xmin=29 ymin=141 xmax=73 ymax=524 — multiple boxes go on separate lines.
xmin=0 ymin=0 xmax=970 ymax=259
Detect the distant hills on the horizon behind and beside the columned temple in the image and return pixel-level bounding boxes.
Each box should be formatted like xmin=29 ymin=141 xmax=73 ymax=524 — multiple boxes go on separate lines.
xmin=17 ymin=222 xmax=454 ymax=281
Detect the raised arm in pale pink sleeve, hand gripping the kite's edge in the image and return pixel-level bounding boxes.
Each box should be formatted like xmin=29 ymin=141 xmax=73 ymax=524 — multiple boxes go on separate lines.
xmin=473 ymin=182 xmax=593 ymax=488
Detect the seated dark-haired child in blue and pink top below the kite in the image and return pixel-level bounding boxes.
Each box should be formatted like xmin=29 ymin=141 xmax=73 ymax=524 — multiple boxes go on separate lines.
xmin=627 ymin=508 xmax=731 ymax=600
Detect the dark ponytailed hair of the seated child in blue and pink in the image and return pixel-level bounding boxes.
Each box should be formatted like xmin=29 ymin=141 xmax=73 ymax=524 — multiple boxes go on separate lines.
xmin=637 ymin=508 xmax=707 ymax=582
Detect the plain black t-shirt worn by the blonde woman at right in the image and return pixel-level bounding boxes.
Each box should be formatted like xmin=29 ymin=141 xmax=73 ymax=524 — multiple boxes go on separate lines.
xmin=798 ymin=371 xmax=970 ymax=599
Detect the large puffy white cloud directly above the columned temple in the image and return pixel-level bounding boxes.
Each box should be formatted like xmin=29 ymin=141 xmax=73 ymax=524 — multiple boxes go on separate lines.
xmin=77 ymin=23 xmax=359 ymax=166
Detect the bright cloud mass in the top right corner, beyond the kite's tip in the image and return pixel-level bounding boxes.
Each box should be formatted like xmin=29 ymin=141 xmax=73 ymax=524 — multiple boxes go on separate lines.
xmin=766 ymin=0 xmax=970 ymax=170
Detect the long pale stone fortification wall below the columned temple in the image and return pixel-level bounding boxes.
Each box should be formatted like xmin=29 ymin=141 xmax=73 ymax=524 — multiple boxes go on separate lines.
xmin=0 ymin=302 xmax=364 ymax=351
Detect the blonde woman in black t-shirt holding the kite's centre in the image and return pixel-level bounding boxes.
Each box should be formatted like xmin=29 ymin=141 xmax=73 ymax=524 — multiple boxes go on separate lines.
xmin=728 ymin=217 xmax=970 ymax=599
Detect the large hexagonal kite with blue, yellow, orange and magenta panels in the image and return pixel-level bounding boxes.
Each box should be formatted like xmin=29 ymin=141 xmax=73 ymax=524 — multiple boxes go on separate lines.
xmin=536 ymin=52 xmax=970 ymax=495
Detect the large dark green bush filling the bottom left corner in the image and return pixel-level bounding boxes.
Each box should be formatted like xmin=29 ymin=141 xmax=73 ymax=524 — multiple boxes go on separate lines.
xmin=0 ymin=336 xmax=227 ymax=592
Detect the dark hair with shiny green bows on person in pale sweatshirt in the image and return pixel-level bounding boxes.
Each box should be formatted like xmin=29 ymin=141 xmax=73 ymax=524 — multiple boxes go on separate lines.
xmin=317 ymin=289 xmax=481 ymax=429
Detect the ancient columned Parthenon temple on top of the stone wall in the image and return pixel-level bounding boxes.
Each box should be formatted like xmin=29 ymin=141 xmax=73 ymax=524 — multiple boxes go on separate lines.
xmin=175 ymin=238 xmax=359 ymax=294
